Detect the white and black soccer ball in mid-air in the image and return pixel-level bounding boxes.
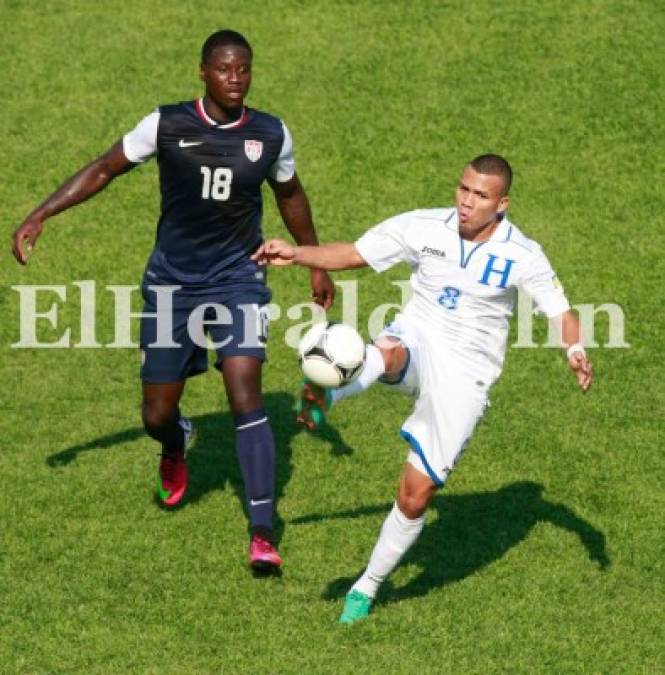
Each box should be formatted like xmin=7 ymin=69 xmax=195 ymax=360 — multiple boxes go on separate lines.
xmin=298 ymin=321 xmax=365 ymax=388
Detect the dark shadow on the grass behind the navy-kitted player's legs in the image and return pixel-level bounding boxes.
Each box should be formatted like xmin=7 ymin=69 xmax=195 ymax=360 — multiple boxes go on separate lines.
xmin=46 ymin=392 xmax=353 ymax=539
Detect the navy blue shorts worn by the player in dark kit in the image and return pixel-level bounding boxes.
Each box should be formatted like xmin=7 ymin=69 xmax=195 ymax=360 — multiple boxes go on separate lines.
xmin=140 ymin=286 xmax=270 ymax=383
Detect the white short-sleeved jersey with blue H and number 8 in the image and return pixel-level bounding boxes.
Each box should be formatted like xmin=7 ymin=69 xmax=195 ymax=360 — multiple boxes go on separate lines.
xmin=355 ymin=208 xmax=570 ymax=386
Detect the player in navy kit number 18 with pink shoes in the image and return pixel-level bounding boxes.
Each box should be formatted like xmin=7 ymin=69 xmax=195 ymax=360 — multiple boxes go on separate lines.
xmin=13 ymin=30 xmax=334 ymax=570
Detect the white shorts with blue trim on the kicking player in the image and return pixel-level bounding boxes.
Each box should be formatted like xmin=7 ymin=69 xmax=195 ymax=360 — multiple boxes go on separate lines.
xmin=377 ymin=314 xmax=488 ymax=486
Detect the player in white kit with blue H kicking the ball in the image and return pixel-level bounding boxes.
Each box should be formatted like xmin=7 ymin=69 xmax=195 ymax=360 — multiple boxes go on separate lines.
xmin=255 ymin=155 xmax=592 ymax=623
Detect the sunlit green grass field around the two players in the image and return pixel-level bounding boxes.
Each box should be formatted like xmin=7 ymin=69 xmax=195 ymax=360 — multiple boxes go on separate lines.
xmin=0 ymin=0 xmax=665 ymax=675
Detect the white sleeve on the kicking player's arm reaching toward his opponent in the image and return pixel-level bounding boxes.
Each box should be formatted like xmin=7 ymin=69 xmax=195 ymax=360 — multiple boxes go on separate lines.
xmin=355 ymin=211 xmax=420 ymax=272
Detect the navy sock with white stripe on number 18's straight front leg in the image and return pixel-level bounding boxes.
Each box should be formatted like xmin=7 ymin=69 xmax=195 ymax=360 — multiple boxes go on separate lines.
xmin=233 ymin=408 xmax=275 ymax=536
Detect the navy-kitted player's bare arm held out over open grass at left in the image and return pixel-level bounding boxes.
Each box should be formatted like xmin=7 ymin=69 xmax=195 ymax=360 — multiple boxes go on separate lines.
xmin=12 ymin=141 xmax=136 ymax=265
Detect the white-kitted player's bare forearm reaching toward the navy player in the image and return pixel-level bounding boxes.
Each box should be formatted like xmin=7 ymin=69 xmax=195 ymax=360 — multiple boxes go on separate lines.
xmin=252 ymin=239 xmax=367 ymax=271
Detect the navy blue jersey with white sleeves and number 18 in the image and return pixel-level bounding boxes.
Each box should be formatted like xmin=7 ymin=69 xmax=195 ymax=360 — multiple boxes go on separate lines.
xmin=123 ymin=99 xmax=294 ymax=290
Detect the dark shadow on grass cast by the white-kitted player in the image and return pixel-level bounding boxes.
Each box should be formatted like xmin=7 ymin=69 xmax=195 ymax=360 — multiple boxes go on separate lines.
xmin=298 ymin=481 xmax=610 ymax=603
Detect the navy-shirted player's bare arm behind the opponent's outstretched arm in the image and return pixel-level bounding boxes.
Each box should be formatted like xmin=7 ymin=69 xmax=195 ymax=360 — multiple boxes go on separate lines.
xmin=268 ymin=174 xmax=335 ymax=309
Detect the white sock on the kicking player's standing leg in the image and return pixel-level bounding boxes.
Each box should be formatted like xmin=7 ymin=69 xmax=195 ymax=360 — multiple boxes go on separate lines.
xmin=352 ymin=502 xmax=425 ymax=598
